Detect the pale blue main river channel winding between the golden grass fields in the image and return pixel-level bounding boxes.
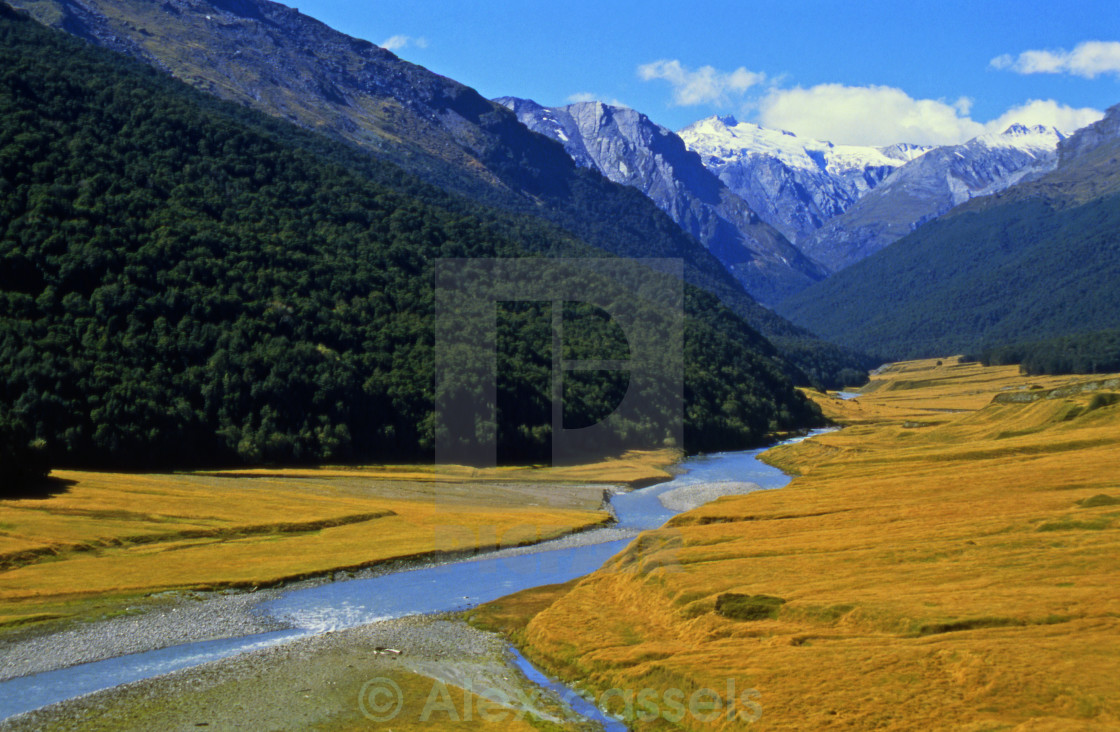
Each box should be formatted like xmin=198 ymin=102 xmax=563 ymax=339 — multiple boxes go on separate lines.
xmin=0 ymin=429 xmax=824 ymax=720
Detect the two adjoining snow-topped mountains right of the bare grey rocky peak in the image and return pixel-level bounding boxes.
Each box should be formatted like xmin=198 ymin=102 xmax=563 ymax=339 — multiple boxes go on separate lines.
xmin=680 ymin=116 xmax=1066 ymax=278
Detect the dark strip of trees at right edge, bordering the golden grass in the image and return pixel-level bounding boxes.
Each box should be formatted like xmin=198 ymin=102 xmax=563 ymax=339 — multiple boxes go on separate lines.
xmin=970 ymin=328 xmax=1120 ymax=374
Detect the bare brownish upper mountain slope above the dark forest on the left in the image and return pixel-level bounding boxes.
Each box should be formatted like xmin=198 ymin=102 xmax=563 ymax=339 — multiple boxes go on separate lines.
xmin=18 ymin=0 xmax=865 ymax=384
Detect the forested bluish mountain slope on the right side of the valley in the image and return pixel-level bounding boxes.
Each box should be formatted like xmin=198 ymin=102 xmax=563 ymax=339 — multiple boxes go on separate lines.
xmin=781 ymin=105 xmax=1120 ymax=357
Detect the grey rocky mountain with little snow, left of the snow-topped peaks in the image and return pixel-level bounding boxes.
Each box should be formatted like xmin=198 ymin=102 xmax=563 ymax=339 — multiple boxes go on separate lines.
xmin=494 ymin=97 xmax=825 ymax=303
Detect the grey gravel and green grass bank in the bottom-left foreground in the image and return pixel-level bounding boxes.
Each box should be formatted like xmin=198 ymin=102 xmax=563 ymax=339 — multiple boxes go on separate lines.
xmin=0 ymin=616 xmax=598 ymax=732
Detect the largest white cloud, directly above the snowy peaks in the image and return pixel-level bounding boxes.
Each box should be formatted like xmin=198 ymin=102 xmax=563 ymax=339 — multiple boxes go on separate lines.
xmin=758 ymin=84 xmax=984 ymax=146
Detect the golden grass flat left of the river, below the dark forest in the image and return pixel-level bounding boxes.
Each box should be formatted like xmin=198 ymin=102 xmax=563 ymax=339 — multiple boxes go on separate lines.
xmin=0 ymin=450 xmax=678 ymax=627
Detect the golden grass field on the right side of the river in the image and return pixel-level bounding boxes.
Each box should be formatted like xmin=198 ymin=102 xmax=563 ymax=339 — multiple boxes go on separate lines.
xmin=486 ymin=359 xmax=1120 ymax=731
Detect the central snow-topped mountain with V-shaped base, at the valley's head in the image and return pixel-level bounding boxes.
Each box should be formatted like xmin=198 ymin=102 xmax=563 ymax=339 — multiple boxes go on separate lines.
xmin=679 ymin=116 xmax=931 ymax=244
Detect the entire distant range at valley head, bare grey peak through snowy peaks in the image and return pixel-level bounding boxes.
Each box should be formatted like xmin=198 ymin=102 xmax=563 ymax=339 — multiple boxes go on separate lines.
xmin=495 ymin=97 xmax=1066 ymax=297
